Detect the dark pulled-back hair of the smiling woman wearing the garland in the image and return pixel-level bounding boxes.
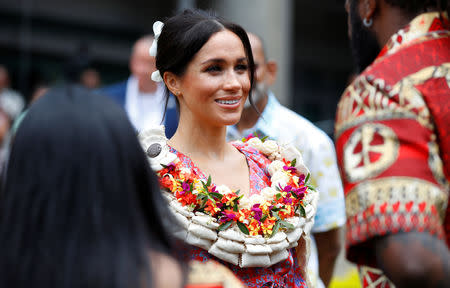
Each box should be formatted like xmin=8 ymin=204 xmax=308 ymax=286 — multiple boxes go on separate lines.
xmin=156 ymin=9 xmax=255 ymax=112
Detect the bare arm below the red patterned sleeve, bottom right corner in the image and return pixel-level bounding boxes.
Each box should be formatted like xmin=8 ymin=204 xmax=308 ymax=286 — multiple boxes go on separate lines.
xmin=375 ymin=232 xmax=450 ymax=288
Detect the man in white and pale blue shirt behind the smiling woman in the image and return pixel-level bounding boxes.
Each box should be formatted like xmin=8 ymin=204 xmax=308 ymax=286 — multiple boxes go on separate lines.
xmin=227 ymin=33 xmax=345 ymax=287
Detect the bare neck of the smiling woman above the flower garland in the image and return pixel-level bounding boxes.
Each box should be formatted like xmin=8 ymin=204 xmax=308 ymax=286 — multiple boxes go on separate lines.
xmin=169 ymin=113 xmax=229 ymax=160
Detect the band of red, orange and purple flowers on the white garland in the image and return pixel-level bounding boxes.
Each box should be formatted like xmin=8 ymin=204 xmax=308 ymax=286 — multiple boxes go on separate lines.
xmin=157 ymin=135 xmax=314 ymax=238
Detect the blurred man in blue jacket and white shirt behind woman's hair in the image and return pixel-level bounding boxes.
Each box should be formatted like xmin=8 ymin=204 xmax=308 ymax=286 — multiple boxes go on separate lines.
xmin=100 ymin=36 xmax=178 ymax=138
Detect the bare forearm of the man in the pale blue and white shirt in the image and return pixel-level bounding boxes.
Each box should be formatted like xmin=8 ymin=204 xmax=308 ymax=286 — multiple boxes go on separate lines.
xmin=314 ymin=228 xmax=342 ymax=287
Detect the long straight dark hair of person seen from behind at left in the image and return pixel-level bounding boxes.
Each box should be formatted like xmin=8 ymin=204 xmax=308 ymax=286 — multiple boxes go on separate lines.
xmin=0 ymin=86 xmax=184 ymax=288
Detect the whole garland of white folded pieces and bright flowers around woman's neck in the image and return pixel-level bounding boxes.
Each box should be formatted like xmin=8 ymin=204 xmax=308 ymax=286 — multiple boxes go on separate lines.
xmin=139 ymin=126 xmax=318 ymax=267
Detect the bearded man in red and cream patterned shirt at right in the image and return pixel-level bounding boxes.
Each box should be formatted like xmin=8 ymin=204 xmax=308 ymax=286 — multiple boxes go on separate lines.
xmin=335 ymin=0 xmax=450 ymax=288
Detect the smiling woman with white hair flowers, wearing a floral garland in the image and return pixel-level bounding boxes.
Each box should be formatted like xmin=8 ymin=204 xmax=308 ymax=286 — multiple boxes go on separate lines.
xmin=140 ymin=10 xmax=311 ymax=287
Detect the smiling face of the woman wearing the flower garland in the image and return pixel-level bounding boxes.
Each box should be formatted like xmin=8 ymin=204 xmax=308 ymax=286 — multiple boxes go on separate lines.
xmin=173 ymin=30 xmax=250 ymax=126
